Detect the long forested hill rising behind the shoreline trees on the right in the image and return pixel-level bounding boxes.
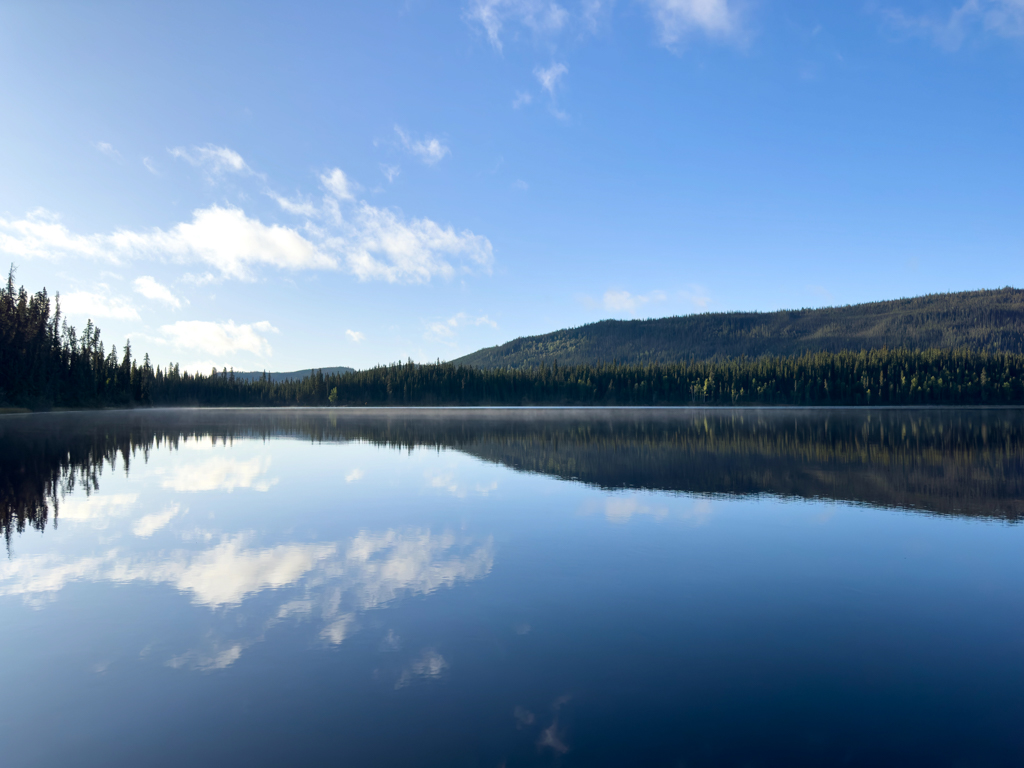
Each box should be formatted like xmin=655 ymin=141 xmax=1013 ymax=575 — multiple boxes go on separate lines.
xmin=453 ymin=288 xmax=1024 ymax=368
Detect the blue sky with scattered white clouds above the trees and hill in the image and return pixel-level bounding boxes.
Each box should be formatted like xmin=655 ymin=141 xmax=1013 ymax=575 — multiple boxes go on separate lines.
xmin=0 ymin=0 xmax=1024 ymax=371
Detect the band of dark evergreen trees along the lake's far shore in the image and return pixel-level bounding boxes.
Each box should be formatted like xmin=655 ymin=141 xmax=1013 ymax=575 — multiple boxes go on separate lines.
xmin=6 ymin=271 xmax=1024 ymax=410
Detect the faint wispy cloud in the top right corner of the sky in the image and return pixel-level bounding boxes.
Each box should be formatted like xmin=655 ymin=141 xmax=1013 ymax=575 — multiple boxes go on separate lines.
xmin=882 ymin=0 xmax=1024 ymax=51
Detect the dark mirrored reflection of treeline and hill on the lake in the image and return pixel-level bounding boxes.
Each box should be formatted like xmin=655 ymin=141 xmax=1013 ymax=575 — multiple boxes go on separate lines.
xmin=0 ymin=409 xmax=1024 ymax=541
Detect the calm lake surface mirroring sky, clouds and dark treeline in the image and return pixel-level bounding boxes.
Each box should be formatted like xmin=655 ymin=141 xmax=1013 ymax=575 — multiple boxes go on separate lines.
xmin=0 ymin=411 xmax=1024 ymax=768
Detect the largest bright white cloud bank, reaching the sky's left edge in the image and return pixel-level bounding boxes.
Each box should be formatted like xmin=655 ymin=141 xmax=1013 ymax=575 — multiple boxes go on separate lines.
xmin=0 ymin=169 xmax=494 ymax=285
